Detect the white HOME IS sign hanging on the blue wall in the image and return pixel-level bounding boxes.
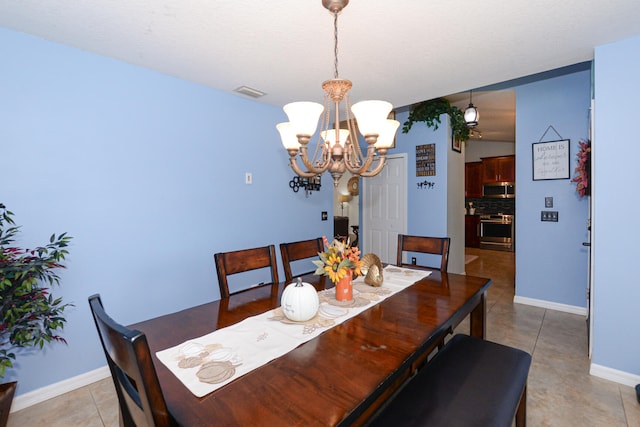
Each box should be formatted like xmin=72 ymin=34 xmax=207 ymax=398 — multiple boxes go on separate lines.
xmin=531 ymin=139 xmax=570 ymax=181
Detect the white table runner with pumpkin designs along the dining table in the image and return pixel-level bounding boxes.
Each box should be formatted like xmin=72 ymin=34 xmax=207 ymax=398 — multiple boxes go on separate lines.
xmin=156 ymin=266 xmax=431 ymax=397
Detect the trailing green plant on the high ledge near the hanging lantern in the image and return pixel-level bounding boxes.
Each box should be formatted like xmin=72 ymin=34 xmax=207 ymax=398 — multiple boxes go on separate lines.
xmin=402 ymin=98 xmax=469 ymax=141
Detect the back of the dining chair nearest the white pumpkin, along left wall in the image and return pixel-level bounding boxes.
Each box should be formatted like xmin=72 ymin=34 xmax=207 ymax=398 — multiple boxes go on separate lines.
xmin=214 ymin=245 xmax=278 ymax=298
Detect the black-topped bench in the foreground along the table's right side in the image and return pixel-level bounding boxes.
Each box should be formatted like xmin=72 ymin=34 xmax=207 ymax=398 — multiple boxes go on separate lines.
xmin=368 ymin=335 xmax=531 ymax=427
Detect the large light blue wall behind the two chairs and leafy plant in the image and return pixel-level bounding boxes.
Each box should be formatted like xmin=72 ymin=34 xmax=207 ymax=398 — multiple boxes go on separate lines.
xmin=0 ymin=28 xmax=333 ymax=394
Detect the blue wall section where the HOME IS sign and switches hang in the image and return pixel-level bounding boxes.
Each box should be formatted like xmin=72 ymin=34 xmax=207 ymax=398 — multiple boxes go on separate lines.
xmin=515 ymin=70 xmax=591 ymax=309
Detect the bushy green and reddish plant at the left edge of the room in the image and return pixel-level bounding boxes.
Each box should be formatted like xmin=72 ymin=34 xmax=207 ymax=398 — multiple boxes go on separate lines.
xmin=0 ymin=203 xmax=72 ymax=377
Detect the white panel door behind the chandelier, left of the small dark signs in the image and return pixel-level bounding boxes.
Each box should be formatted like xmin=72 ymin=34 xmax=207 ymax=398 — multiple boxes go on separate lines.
xmin=360 ymin=154 xmax=407 ymax=264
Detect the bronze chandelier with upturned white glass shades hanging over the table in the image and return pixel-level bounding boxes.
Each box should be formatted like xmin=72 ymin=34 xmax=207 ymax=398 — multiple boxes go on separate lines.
xmin=276 ymin=0 xmax=400 ymax=187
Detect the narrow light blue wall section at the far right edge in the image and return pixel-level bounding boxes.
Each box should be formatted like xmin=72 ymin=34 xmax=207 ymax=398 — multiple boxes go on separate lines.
xmin=592 ymin=33 xmax=640 ymax=382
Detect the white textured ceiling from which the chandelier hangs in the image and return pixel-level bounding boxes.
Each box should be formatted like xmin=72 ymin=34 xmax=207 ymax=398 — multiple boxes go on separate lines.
xmin=0 ymin=0 xmax=640 ymax=140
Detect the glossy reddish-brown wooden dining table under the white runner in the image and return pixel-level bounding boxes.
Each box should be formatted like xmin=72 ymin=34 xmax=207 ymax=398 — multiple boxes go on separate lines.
xmin=130 ymin=271 xmax=491 ymax=426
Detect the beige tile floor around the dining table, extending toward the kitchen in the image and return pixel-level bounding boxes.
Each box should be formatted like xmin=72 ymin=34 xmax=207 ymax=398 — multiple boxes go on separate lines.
xmin=8 ymin=248 xmax=640 ymax=427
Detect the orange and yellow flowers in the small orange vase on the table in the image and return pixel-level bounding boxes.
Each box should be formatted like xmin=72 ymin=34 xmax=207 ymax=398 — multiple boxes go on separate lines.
xmin=313 ymin=236 xmax=362 ymax=283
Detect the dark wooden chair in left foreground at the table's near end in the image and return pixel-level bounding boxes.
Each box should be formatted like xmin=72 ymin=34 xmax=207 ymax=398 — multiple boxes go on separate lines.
xmin=89 ymin=294 xmax=178 ymax=427
